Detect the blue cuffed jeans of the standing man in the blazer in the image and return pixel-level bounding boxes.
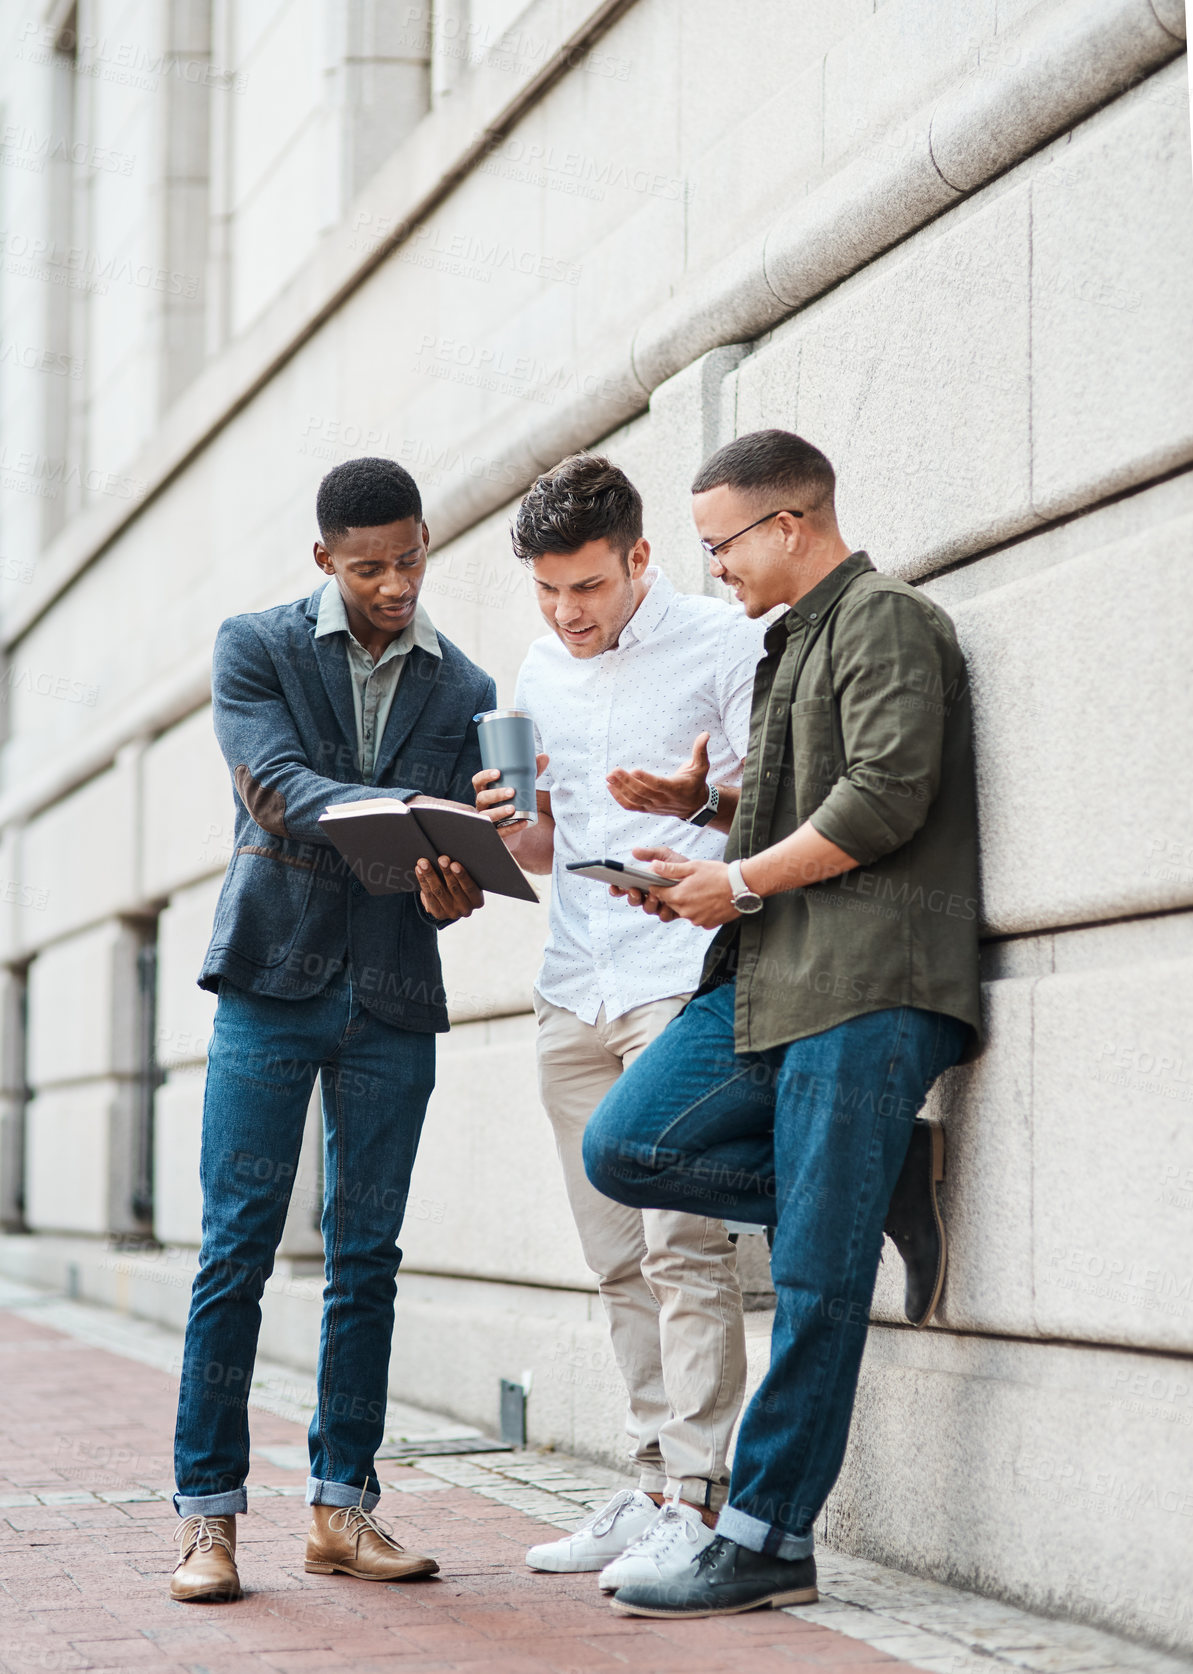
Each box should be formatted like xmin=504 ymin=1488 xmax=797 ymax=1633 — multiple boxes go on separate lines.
xmin=174 ymin=971 xmax=435 ymax=1517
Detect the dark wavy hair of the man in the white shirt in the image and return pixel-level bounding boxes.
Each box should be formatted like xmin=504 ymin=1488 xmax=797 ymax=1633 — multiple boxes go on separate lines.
xmin=510 ymin=454 xmax=643 ymax=564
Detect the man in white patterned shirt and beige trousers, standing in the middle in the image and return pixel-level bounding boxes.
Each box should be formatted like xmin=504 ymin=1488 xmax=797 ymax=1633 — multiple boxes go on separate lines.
xmin=474 ymin=454 xmax=761 ymax=1590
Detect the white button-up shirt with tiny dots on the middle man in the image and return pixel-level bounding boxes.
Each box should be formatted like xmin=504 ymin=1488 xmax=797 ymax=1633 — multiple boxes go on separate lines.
xmin=515 ymin=566 xmax=765 ymax=1023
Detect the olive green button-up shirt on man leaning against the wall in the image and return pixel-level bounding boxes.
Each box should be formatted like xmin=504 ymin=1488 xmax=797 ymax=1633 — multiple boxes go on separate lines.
xmin=703 ymin=552 xmax=981 ymax=1051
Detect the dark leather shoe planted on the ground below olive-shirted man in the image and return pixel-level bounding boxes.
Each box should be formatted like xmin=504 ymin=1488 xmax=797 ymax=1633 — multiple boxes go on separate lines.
xmin=612 ymin=1535 xmax=818 ymax=1615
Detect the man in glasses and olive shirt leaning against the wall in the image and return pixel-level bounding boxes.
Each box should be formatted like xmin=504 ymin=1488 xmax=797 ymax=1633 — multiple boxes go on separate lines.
xmin=584 ymin=430 xmax=981 ymax=1615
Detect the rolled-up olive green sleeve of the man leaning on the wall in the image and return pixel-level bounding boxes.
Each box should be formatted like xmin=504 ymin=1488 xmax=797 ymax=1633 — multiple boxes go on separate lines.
xmin=812 ymin=591 xmax=955 ymax=865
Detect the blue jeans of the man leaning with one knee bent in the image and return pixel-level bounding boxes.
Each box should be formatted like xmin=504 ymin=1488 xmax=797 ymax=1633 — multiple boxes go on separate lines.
xmin=584 ymin=983 xmax=969 ymax=1558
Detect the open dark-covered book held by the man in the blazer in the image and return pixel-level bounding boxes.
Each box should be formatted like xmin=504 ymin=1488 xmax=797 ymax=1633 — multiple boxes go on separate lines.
xmin=320 ymin=797 xmax=539 ymax=901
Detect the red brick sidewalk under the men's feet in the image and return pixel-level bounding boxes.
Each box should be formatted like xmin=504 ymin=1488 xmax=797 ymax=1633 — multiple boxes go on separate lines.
xmin=0 ymin=1312 xmax=905 ymax=1674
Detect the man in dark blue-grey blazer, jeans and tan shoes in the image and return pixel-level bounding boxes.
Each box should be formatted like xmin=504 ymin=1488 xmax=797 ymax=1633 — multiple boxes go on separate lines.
xmin=171 ymin=459 xmax=495 ymax=1600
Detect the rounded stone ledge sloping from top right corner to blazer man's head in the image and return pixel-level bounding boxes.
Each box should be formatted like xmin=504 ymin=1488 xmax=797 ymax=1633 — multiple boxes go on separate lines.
xmin=428 ymin=0 xmax=1183 ymax=539
